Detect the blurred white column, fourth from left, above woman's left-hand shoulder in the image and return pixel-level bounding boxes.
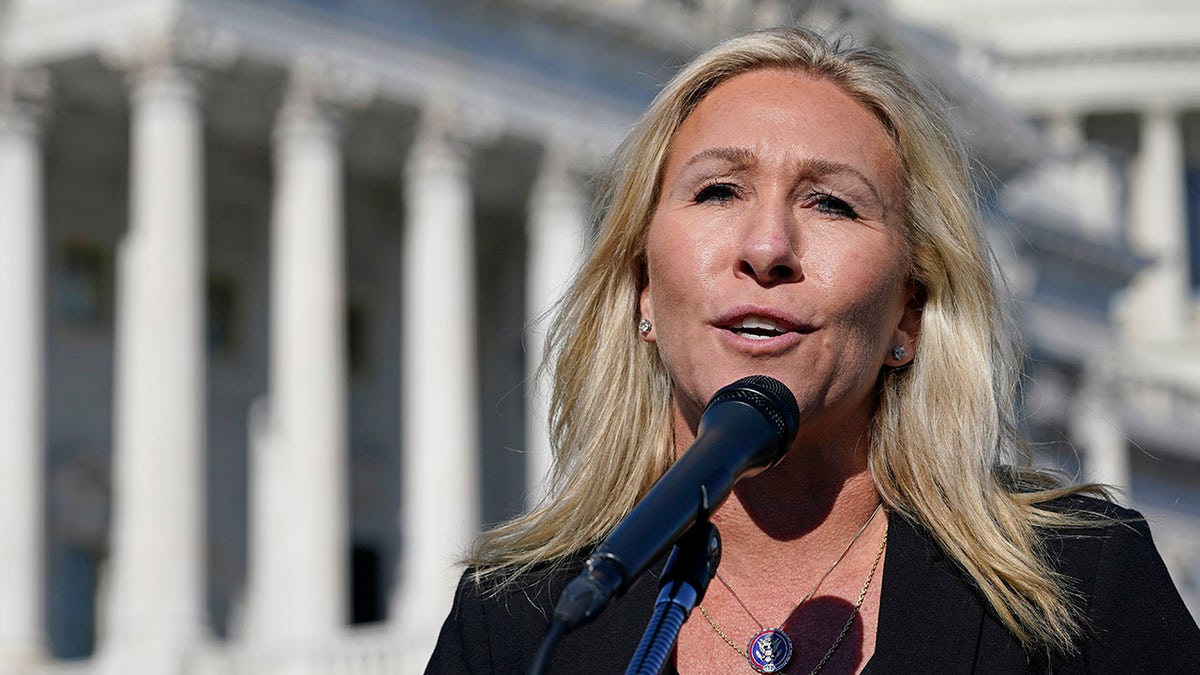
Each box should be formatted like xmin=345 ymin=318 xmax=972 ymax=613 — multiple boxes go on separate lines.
xmin=391 ymin=100 xmax=479 ymax=655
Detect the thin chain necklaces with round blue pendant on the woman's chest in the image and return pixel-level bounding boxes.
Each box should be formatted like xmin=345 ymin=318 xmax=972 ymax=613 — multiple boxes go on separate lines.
xmin=700 ymin=504 xmax=888 ymax=675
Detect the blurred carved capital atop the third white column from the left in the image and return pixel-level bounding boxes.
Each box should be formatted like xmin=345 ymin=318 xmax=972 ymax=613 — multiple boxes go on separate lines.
xmin=275 ymin=54 xmax=377 ymax=142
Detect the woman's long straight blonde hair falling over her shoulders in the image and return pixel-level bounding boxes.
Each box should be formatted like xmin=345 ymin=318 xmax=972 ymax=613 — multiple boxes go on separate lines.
xmin=467 ymin=28 xmax=1104 ymax=652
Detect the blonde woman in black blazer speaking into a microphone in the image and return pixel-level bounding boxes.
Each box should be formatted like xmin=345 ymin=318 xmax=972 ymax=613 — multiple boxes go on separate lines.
xmin=428 ymin=24 xmax=1200 ymax=674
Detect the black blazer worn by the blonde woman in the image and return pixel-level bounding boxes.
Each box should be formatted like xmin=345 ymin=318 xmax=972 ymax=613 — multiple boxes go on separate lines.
xmin=425 ymin=497 xmax=1200 ymax=675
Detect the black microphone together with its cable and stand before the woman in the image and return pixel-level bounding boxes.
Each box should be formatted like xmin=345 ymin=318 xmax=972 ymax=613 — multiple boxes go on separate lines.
xmin=529 ymin=375 xmax=800 ymax=675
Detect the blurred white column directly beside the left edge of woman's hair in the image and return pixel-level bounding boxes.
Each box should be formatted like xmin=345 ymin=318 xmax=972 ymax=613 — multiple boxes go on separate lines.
xmin=524 ymin=144 xmax=588 ymax=507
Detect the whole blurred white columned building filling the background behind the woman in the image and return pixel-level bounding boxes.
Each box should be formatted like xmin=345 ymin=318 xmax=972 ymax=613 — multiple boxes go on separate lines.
xmin=0 ymin=0 xmax=1200 ymax=674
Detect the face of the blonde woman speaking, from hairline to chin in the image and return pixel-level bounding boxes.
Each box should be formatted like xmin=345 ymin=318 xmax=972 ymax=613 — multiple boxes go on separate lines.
xmin=641 ymin=70 xmax=919 ymax=446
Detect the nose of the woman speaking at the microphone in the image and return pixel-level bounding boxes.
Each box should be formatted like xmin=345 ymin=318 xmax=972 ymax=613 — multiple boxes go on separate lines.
xmin=738 ymin=200 xmax=804 ymax=285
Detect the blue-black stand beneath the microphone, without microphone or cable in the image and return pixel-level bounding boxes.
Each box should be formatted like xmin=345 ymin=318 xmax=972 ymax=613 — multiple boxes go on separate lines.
xmin=625 ymin=519 xmax=721 ymax=675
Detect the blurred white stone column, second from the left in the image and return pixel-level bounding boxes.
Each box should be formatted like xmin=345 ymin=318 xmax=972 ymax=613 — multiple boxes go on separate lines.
xmin=102 ymin=50 xmax=206 ymax=673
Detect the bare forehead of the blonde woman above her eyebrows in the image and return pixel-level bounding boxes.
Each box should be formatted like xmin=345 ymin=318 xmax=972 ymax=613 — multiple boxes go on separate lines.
xmin=666 ymin=68 xmax=901 ymax=192
